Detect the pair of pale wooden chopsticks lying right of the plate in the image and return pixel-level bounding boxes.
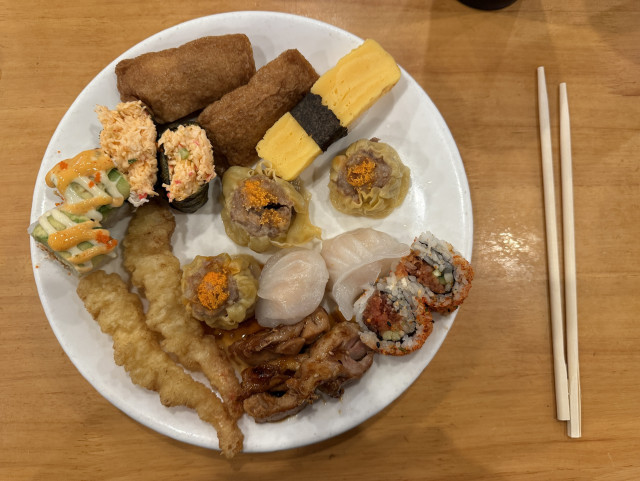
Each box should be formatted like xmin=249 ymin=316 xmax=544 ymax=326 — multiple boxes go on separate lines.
xmin=538 ymin=67 xmax=582 ymax=438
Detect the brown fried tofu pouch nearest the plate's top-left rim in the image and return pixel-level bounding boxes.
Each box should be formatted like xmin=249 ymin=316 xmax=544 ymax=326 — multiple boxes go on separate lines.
xmin=116 ymin=34 xmax=256 ymax=124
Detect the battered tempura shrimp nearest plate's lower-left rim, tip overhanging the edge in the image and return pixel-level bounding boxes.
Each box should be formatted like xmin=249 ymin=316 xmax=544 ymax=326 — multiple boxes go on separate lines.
xmin=78 ymin=271 xmax=243 ymax=458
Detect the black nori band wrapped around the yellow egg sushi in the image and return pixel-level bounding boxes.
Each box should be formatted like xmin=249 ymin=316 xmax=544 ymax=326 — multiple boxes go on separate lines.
xmin=291 ymin=92 xmax=347 ymax=152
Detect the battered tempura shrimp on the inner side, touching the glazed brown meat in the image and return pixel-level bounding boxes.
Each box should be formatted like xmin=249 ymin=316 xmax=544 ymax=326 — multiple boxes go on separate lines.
xmin=123 ymin=202 xmax=242 ymax=419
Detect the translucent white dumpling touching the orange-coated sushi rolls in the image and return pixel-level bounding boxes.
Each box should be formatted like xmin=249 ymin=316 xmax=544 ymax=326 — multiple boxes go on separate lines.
xmin=321 ymin=228 xmax=410 ymax=319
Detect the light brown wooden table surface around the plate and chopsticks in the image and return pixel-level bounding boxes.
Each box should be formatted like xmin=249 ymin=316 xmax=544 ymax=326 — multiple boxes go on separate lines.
xmin=0 ymin=0 xmax=640 ymax=481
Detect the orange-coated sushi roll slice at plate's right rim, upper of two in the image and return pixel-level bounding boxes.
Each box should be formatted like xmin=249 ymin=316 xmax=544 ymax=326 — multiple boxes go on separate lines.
xmin=395 ymin=232 xmax=473 ymax=313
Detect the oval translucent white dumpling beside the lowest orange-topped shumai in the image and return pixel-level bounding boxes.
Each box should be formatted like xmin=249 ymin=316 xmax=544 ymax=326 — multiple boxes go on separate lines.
xmin=256 ymin=248 xmax=329 ymax=327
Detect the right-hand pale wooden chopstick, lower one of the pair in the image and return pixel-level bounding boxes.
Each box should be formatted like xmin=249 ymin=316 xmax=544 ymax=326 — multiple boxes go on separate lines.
xmin=560 ymin=83 xmax=582 ymax=438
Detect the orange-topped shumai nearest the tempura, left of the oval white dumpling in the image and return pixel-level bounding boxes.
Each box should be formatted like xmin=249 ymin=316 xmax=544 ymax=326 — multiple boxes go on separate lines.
xmin=181 ymin=253 xmax=260 ymax=329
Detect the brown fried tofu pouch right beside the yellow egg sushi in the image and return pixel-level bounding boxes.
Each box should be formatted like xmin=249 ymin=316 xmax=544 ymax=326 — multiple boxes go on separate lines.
xmin=198 ymin=49 xmax=318 ymax=167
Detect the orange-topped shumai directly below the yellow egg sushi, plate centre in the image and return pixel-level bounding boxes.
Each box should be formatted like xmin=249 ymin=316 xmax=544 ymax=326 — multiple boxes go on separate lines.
xmin=221 ymin=164 xmax=321 ymax=252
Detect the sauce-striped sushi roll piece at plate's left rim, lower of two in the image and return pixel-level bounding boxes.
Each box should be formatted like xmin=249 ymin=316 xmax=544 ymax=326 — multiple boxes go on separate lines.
xmin=29 ymin=209 xmax=118 ymax=274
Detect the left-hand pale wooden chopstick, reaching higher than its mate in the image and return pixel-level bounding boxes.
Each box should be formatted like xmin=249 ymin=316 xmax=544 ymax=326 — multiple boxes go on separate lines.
xmin=538 ymin=67 xmax=570 ymax=421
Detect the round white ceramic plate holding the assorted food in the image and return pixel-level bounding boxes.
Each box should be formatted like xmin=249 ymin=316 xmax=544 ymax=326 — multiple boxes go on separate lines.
xmin=31 ymin=12 xmax=473 ymax=452
